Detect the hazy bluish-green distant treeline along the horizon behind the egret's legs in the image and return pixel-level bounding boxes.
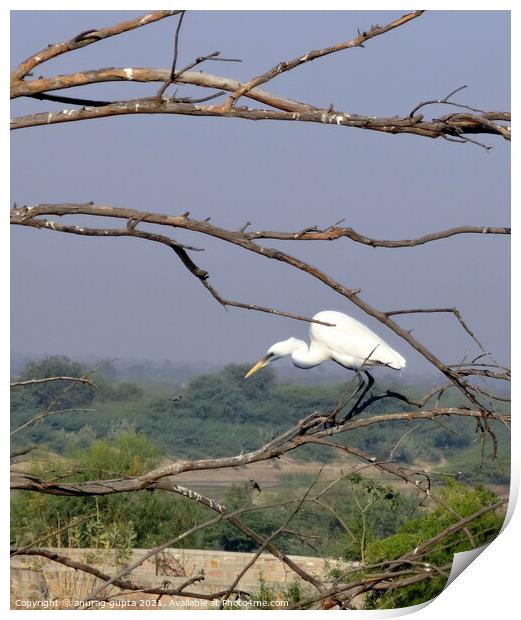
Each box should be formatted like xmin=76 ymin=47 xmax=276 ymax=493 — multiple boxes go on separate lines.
xmin=11 ymin=356 xmax=510 ymax=484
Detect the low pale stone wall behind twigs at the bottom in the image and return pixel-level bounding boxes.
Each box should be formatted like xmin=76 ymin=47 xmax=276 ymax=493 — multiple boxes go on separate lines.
xmin=11 ymin=549 xmax=350 ymax=609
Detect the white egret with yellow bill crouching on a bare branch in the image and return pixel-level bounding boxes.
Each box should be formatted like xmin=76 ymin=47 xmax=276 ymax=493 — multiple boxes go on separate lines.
xmin=244 ymin=310 xmax=405 ymax=418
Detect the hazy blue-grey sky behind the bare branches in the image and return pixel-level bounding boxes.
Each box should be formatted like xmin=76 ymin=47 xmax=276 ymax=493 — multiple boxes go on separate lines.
xmin=11 ymin=11 xmax=510 ymax=372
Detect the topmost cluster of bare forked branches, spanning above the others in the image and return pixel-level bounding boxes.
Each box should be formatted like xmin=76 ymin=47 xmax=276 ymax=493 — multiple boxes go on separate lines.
xmin=11 ymin=11 xmax=511 ymax=143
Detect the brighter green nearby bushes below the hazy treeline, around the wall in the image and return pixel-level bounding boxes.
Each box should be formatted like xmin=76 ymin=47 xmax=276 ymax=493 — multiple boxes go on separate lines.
xmin=11 ymin=428 xmax=502 ymax=608
